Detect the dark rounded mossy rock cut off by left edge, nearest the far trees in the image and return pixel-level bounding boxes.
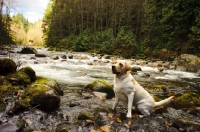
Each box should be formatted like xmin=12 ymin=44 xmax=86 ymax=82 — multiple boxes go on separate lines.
xmin=0 ymin=58 xmax=17 ymax=76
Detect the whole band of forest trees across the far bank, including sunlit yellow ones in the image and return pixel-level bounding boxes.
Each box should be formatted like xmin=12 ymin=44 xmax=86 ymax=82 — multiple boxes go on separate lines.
xmin=0 ymin=0 xmax=200 ymax=58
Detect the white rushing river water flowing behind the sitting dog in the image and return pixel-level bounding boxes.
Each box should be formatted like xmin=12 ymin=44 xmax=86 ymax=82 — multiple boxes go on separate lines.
xmin=13 ymin=48 xmax=200 ymax=85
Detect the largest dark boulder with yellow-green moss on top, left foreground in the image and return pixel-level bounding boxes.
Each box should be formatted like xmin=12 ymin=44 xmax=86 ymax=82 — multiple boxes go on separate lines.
xmin=13 ymin=84 xmax=60 ymax=113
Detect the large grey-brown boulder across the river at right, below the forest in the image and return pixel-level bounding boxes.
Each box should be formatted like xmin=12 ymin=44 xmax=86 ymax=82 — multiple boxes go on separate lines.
xmin=175 ymin=54 xmax=200 ymax=72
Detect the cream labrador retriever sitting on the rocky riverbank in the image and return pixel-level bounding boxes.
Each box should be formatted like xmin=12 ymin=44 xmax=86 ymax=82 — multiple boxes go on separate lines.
xmin=112 ymin=61 xmax=174 ymax=118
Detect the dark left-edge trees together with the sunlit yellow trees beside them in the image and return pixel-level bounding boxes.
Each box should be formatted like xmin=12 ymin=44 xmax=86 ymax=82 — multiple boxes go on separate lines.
xmin=0 ymin=0 xmax=43 ymax=46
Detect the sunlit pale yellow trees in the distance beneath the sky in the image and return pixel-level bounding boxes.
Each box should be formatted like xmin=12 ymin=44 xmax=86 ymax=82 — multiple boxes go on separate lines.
xmin=11 ymin=13 xmax=43 ymax=46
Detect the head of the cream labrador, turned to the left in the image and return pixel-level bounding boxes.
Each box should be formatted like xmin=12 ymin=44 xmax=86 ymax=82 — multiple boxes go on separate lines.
xmin=112 ymin=60 xmax=130 ymax=74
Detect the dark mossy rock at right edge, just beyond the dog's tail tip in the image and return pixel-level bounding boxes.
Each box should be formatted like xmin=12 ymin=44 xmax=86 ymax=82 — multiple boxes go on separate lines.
xmin=173 ymin=92 xmax=200 ymax=109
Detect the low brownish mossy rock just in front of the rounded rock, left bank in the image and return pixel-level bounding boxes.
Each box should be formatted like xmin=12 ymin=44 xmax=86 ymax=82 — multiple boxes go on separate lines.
xmin=8 ymin=71 xmax=31 ymax=85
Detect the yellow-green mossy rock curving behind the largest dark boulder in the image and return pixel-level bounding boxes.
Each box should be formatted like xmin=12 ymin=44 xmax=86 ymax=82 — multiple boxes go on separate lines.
xmin=34 ymin=76 xmax=63 ymax=96
